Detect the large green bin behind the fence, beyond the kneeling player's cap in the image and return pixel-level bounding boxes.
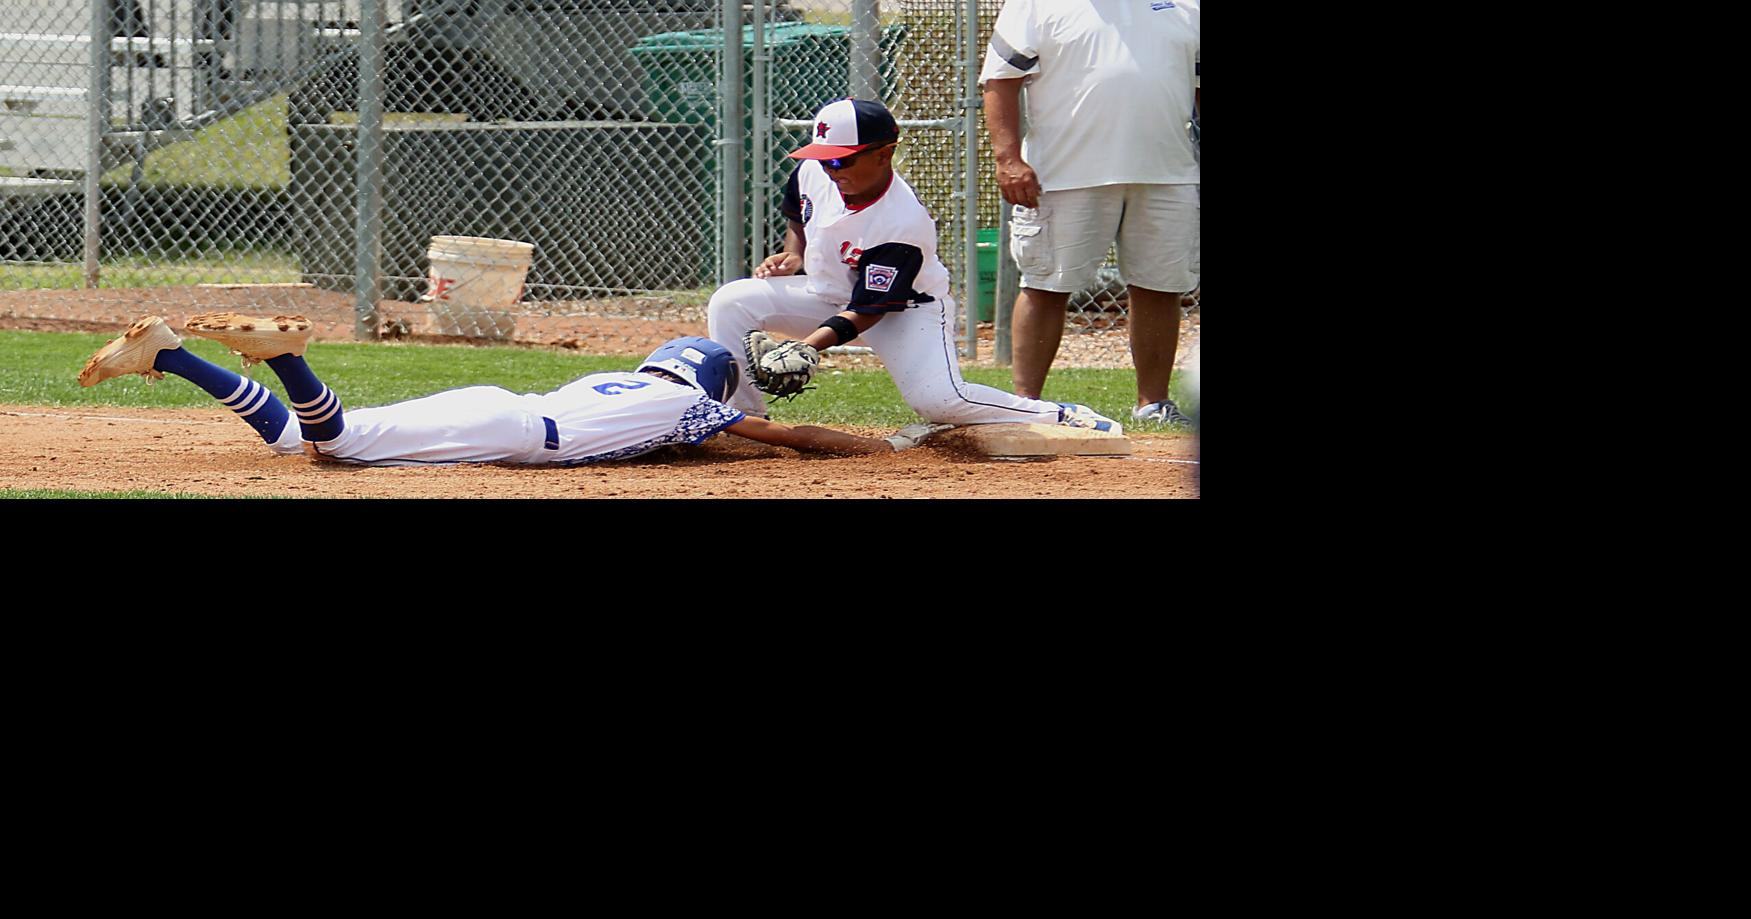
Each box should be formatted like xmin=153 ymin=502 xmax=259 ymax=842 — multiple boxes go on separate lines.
xmin=629 ymin=23 xmax=907 ymax=277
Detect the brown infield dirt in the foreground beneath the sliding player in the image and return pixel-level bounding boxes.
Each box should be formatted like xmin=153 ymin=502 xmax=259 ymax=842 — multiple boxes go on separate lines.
xmin=0 ymin=406 xmax=1199 ymax=499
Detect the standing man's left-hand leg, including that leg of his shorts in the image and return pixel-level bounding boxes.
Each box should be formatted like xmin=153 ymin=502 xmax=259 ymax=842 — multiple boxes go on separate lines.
xmin=1010 ymin=186 xmax=1124 ymax=399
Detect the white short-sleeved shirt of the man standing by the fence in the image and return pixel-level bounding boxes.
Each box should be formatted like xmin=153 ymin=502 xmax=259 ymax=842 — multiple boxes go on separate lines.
xmin=979 ymin=0 xmax=1203 ymax=191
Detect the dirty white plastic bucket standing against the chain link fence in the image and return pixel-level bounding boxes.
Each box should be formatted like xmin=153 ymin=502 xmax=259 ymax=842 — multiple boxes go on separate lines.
xmin=420 ymin=236 xmax=536 ymax=338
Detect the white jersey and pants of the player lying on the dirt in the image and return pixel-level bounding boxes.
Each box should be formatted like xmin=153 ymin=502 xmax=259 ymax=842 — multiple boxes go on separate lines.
xmin=308 ymin=371 xmax=744 ymax=466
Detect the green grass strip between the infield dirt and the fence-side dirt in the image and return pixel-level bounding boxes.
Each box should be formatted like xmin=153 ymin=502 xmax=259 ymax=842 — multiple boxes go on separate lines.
xmin=0 ymin=331 xmax=1189 ymax=427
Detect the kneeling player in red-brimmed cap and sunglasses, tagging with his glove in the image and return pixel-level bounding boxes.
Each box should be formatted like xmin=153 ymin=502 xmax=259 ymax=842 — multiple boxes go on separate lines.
xmin=709 ymin=100 xmax=1124 ymax=434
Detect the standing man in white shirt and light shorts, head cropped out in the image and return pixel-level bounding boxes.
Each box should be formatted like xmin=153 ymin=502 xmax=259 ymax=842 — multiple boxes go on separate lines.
xmin=981 ymin=0 xmax=1201 ymax=424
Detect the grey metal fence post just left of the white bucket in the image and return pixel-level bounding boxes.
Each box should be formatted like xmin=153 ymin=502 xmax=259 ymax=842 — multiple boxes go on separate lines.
xmin=352 ymin=0 xmax=383 ymax=341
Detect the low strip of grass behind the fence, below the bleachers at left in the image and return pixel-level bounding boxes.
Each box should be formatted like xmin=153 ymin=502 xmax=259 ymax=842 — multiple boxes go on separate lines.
xmin=0 ymin=249 xmax=303 ymax=291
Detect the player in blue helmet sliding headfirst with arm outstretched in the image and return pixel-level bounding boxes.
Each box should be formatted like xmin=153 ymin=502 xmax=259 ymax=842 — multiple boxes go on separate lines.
xmin=79 ymin=313 xmax=947 ymax=466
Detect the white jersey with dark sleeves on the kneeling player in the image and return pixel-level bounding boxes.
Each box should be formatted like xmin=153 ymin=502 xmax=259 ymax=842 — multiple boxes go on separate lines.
xmin=781 ymin=159 xmax=949 ymax=313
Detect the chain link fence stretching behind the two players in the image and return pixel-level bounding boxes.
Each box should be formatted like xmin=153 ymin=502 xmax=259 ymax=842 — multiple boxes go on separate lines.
xmin=0 ymin=0 xmax=1148 ymax=365
